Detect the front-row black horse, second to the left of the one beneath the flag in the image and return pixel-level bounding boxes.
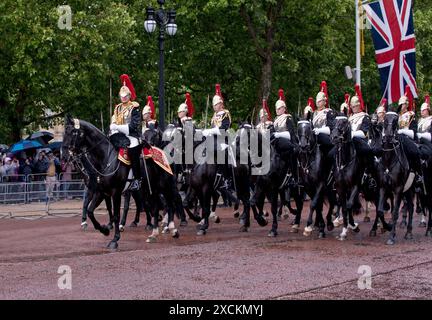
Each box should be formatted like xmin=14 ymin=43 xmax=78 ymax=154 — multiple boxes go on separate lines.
xmin=293 ymin=120 xmax=336 ymax=238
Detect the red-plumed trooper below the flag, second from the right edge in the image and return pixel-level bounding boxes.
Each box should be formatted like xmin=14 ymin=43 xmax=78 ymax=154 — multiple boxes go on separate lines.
xmin=398 ymin=85 xmax=423 ymax=183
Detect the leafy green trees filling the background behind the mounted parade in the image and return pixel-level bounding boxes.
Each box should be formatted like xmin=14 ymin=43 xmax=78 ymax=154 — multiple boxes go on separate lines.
xmin=0 ymin=0 xmax=432 ymax=142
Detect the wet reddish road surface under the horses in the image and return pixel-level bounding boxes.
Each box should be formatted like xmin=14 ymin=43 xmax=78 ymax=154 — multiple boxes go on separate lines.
xmin=0 ymin=202 xmax=432 ymax=299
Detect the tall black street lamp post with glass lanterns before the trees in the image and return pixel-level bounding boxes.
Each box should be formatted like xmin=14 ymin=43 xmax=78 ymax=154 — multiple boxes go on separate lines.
xmin=144 ymin=0 xmax=177 ymax=130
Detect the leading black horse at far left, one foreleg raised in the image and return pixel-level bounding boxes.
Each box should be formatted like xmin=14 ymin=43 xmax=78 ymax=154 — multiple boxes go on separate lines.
xmin=62 ymin=116 xmax=179 ymax=249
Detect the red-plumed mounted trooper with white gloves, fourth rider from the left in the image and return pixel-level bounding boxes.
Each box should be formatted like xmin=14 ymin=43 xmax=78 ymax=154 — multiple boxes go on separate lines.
xmin=202 ymin=84 xmax=231 ymax=188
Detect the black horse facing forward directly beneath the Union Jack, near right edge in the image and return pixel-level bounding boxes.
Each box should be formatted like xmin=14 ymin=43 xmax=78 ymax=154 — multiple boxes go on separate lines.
xmin=377 ymin=112 xmax=414 ymax=245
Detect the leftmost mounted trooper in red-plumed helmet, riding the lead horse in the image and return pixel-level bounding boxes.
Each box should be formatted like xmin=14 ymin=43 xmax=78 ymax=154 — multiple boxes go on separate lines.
xmin=110 ymin=74 xmax=141 ymax=190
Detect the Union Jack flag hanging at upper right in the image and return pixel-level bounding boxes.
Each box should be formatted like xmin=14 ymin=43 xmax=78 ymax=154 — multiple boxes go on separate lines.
xmin=363 ymin=0 xmax=417 ymax=104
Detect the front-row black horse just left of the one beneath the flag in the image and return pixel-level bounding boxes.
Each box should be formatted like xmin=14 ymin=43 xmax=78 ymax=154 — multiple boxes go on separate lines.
xmin=331 ymin=116 xmax=365 ymax=241
